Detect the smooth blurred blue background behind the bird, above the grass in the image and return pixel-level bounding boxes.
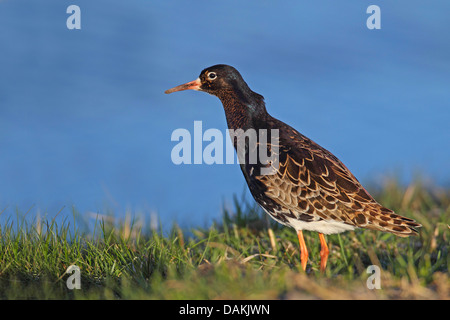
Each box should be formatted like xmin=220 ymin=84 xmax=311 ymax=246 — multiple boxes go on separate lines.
xmin=0 ymin=0 xmax=450 ymax=230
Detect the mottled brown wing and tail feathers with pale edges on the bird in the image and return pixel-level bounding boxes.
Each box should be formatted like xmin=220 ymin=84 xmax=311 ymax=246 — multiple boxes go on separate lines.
xmin=256 ymin=118 xmax=420 ymax=236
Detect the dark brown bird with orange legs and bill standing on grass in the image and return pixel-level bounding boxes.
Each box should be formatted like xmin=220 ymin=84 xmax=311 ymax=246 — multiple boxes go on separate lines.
xmin=165 ymin=64 xmax=421 ymax=272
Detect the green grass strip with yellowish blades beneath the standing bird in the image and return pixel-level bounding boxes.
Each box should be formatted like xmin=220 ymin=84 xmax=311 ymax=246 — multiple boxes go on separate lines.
xmin=0 ymin=179 xmax=450 ymax=299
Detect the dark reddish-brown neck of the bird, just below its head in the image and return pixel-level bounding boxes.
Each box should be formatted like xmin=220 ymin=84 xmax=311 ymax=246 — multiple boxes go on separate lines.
xmin=217 ymin=91 xmax=267 ymax=130
